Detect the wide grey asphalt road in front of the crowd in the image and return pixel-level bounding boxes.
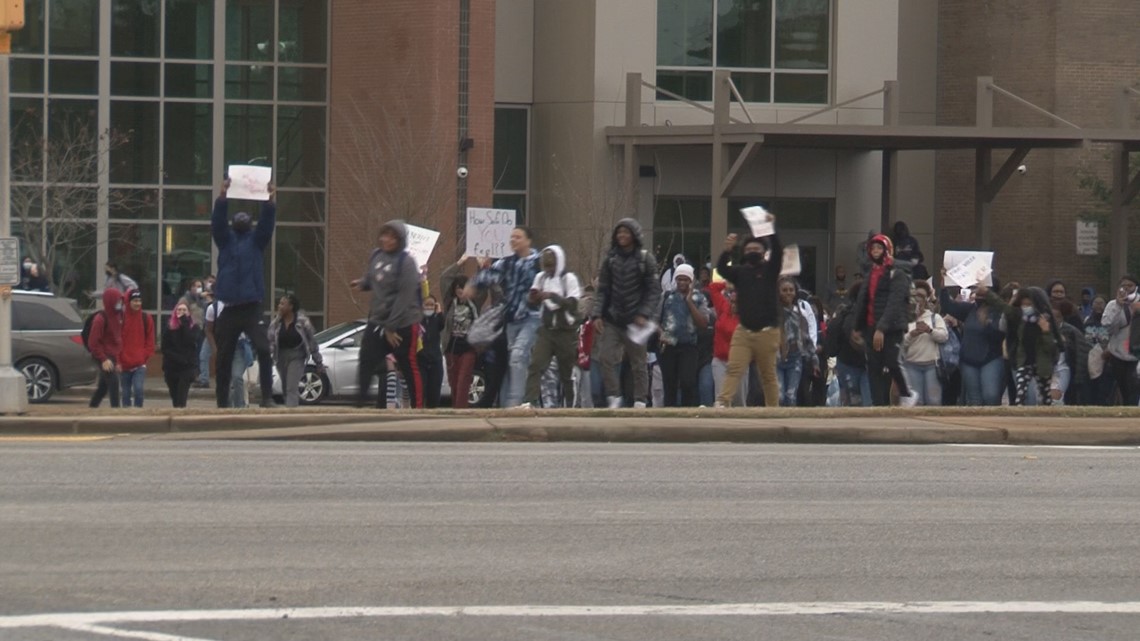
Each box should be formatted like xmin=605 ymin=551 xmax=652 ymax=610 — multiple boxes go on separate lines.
xmin=0 ymin=439 xmax=1140 ymax=641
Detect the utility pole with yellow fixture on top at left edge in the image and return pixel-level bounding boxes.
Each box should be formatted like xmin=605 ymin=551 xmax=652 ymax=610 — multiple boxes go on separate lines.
xmin=0 ymin=0 xmax=27 ymax=414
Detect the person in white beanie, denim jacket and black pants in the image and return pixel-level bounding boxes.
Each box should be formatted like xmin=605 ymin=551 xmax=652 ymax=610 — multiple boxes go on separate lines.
xmin=658 ymin=263 xmax=709 ymax=407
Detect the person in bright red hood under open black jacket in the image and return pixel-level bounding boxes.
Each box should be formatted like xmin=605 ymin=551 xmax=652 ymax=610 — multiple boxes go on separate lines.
xmin=855 ymin=234 xmax=911 ymax=406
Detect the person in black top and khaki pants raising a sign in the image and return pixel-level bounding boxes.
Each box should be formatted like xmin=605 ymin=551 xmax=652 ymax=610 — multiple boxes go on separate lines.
xmin=716 ymin=226 xmax=783 ymax=407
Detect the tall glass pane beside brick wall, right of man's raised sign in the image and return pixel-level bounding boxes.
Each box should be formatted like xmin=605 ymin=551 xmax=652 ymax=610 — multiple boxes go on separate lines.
xmin=274 ymin=106 xmax=325 ymax=187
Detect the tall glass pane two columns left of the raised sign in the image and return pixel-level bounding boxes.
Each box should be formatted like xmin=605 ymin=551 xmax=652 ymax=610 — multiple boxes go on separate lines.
xmin=108 ymin=100 xmax=160 ymax=185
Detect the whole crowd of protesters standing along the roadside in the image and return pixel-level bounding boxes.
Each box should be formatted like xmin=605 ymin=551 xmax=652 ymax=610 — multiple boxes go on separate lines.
xmin=75 ymin=176 xmax=1140 ymax=408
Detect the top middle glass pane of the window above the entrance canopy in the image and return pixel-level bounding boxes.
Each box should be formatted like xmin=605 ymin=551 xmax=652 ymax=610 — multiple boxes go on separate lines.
xmin=716 ymin=0 xmax=770 ymax=68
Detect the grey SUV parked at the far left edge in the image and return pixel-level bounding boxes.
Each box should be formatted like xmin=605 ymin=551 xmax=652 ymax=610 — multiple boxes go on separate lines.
xmin=11 ymin=290 xmax=98 ymax=403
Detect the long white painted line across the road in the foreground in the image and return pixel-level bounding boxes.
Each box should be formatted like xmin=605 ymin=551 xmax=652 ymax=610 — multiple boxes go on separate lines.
xmin=0 ymin=601 xmax=1140 ymax=625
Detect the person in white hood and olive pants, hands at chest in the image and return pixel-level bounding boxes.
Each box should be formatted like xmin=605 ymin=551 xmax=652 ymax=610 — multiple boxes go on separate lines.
xmin=522 ymin=245 xmax=581 ymax=407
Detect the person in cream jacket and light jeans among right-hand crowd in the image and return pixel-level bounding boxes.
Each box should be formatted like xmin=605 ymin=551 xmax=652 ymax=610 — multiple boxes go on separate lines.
xmin=899 ymin=281 xmax=950 ymax=407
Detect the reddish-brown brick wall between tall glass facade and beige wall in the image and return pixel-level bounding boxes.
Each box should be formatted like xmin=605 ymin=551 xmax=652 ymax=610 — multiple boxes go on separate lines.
xmin=326 ymin=0 xmax=495 ymax=324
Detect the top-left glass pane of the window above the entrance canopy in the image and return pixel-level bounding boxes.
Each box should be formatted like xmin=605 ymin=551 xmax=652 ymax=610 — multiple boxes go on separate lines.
xmin=657 ymin=0 xmax=713 ymax=67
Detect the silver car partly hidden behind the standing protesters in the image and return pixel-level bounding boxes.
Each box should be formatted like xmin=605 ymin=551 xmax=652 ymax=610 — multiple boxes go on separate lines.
xmin=274 ymin=319 xmax=487 ymax=405
